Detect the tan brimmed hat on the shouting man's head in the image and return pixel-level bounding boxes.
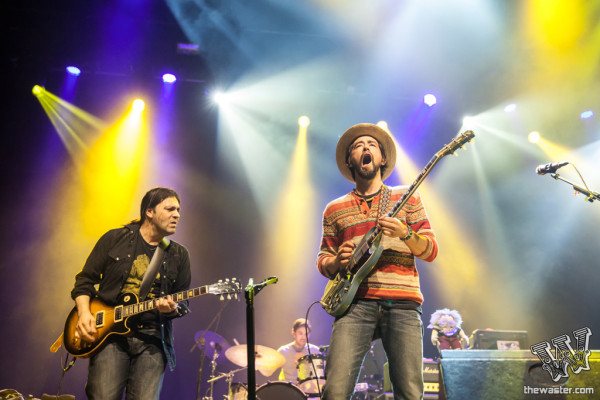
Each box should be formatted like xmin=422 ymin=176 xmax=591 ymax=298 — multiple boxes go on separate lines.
xmin=335 ymin=124 xmax=396 ymax=183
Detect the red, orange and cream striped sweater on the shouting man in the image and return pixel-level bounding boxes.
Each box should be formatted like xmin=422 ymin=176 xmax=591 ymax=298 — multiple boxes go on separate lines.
xmin=317 ymin=186 xmax=438 ymax=304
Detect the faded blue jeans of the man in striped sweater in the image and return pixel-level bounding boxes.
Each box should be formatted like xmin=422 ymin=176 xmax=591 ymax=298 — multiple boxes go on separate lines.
xmin=323 ymin=300 xmax=423 ymax=400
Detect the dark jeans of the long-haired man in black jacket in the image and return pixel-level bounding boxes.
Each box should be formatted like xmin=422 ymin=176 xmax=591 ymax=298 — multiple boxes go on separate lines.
xmin=85 ymin=336 xmax=166 ymax=400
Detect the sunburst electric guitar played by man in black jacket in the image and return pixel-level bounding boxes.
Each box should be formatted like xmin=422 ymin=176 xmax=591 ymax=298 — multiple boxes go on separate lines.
xmin=63 ymin=278 xmax=242 ymax=358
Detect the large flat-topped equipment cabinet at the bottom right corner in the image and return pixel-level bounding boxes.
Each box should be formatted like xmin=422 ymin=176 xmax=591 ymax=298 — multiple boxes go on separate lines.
xmin=440 ymin=350 xmax=600 ymax=400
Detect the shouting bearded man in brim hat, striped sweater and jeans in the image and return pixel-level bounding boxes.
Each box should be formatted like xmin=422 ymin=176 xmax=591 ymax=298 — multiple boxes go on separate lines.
xmin=317 ymin=124 xmax=438 ymax=400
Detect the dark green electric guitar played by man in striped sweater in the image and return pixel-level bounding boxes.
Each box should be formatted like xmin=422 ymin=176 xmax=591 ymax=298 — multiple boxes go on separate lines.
xmin=320 ymin=131 xmax=475 ymax=317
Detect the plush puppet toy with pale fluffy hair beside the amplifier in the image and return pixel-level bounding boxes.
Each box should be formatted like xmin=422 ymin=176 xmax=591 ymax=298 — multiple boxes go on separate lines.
xmin=427 ymin=308 xmax=469 ymax=350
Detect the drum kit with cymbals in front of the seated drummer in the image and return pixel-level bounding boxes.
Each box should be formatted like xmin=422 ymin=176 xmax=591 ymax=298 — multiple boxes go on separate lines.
xmin=195 ymin=331 xmax=325 ymax=400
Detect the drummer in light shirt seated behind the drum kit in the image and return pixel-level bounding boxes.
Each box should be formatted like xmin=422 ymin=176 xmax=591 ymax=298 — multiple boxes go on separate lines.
xmin=277 ymin=318 xmax=320 ymax=384
